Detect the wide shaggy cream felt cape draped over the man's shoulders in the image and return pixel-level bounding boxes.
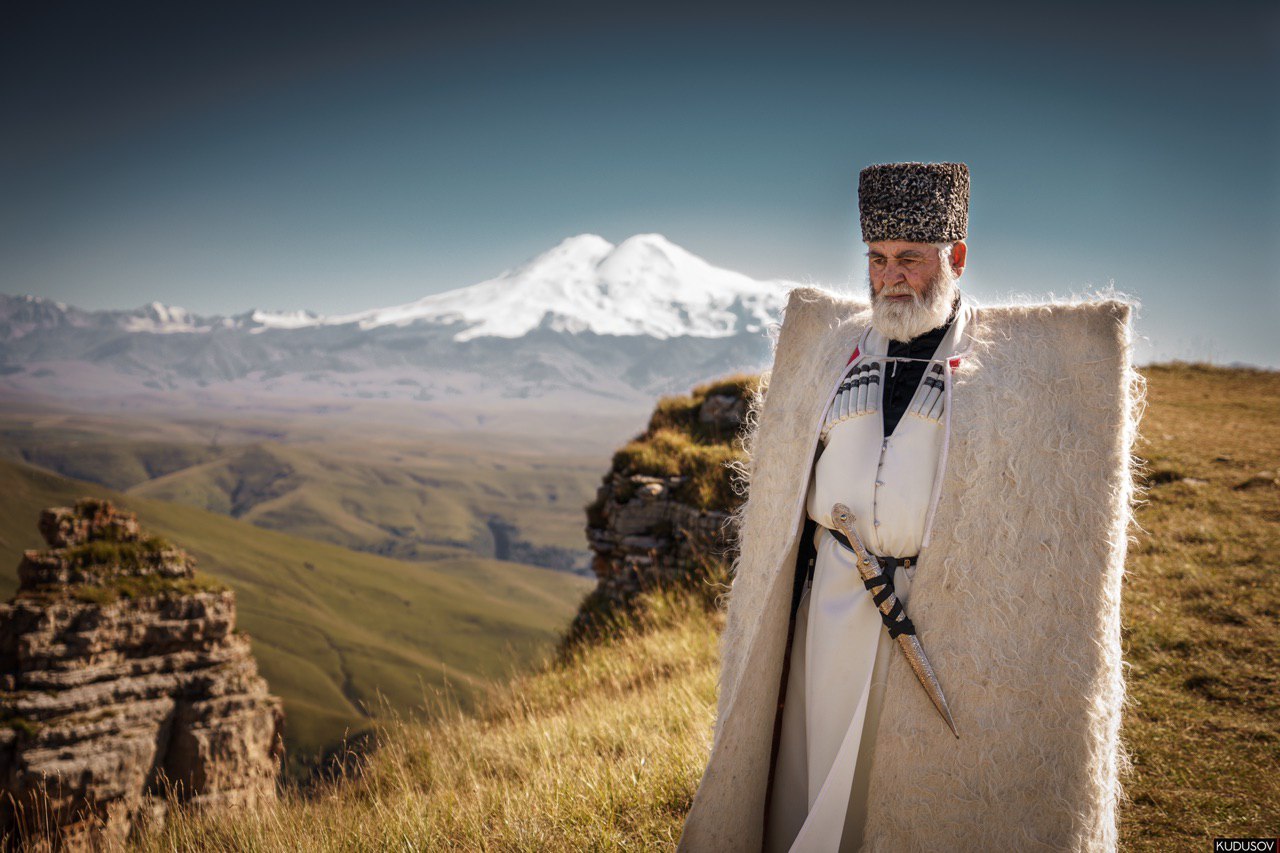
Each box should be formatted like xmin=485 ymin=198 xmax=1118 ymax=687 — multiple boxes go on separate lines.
xmin=680 ymin=288 xmax=1142 ymax=852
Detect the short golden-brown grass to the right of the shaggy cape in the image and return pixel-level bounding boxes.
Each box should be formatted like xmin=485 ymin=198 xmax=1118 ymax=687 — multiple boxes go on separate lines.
xmin=1121 ymin=365 xmax=1280 ymax=850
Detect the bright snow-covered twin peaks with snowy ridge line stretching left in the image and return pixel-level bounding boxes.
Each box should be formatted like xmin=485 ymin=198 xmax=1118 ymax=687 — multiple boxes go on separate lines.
xmin=0 ymin=233 xmax=792 ymax=342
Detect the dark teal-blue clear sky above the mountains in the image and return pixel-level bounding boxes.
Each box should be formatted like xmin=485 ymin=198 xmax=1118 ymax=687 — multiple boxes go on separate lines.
xmin=0 ymin=0 xmax=1280 ymax=366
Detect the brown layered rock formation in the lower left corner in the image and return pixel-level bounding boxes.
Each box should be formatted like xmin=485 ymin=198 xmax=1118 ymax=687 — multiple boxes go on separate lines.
xmin=0 ymin=500 xmax=284 ymax=847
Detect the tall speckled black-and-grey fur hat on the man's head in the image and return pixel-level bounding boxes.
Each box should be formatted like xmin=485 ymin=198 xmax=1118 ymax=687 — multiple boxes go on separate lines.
xmin=858 ymin=163 xmax=969 ymax=243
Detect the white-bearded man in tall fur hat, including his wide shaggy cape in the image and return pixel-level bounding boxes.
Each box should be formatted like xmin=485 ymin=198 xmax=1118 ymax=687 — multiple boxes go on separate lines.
xmin=681 ymin=163 xmax=1137 ymax=850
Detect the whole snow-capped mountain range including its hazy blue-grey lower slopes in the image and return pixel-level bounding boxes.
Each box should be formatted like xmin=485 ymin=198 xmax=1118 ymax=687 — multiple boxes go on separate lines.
xmin=0 ymin=234 xmax=790 ymax=400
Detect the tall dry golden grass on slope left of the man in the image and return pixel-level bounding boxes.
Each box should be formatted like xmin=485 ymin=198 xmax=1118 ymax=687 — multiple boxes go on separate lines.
xmin=136 ymin=594 xmax=721 ymax=850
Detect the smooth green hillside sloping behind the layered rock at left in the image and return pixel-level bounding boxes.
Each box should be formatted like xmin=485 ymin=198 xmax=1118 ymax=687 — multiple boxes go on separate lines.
xmin=0 ymin=461 xmax=591 ymax=773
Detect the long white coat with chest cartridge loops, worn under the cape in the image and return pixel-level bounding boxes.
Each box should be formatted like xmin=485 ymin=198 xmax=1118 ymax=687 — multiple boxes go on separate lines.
xmin=765 ymin=289 xmax=975 ymax=853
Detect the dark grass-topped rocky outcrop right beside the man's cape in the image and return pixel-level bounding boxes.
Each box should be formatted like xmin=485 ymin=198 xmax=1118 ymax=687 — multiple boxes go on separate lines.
xmin=567 ymin=375 xmax=758 ymax=644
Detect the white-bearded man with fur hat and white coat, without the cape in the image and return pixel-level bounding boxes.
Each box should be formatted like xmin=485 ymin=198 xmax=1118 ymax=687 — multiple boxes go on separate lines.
xmin=765 ymin=163 xmax=973 ymax=850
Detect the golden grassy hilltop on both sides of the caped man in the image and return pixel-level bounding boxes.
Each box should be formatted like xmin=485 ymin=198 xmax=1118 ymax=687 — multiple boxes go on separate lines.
xmin=141 ymin=366 xmax=1280 ymax=850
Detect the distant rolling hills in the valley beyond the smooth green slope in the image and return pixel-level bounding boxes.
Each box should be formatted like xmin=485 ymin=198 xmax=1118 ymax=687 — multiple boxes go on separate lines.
xmin=0 ymin=403 xmax=608 ymax=567
